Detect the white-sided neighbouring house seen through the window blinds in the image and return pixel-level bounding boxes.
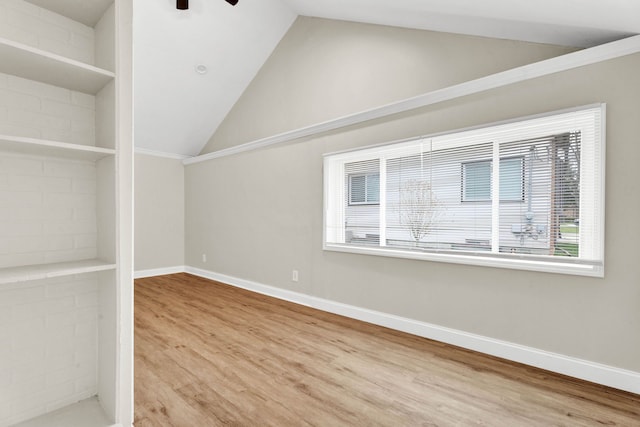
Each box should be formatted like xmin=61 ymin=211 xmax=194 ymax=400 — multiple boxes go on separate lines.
xmin=345 ymin=134 xmax=579 ymax=255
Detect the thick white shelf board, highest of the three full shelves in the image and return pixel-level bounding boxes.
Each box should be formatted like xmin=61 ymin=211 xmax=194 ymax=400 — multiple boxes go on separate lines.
xmin=0 ymin=37 xmax=115 ymax=95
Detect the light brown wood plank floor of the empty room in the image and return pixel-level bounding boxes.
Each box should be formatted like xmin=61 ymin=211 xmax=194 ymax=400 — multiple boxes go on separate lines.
xmin=135 ymin=274 xmax=640 ymax=427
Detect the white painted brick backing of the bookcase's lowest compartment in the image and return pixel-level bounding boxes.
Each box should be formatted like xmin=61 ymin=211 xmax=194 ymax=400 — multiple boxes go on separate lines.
xmin=0 ymin=273 xmax=99 ymax=427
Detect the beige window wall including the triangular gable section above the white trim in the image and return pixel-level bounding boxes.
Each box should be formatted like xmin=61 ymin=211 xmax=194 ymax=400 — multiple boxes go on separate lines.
xmin=185 ymin=19 xmax=640 ymax=372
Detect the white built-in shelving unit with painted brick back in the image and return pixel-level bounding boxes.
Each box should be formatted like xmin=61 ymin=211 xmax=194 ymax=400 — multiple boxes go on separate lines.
xmin=0 ymin=0 xmax=133 ymax=427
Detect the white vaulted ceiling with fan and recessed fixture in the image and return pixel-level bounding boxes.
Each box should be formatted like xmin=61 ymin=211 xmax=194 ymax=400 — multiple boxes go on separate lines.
xmin=131 ymin=0 xmax=640 ymax=156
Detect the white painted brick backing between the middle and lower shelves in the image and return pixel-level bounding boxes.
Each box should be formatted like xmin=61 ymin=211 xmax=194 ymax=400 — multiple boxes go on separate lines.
xmin=0 ymin=152 xmax=97 ymax=268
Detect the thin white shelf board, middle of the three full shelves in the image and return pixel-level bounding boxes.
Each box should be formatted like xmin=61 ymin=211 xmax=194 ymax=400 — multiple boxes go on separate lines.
xmin=0 ymin=134 xmax=115 ymax=161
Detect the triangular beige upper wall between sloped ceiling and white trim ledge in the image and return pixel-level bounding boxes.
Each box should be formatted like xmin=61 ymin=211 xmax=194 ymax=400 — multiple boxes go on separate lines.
xmin=202 ymin=17 xmax=571 ymax=153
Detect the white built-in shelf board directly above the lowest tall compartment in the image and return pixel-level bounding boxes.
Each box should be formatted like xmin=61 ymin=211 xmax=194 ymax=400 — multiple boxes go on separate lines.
xmin=0 ymin=259 xmax=116 ymax=285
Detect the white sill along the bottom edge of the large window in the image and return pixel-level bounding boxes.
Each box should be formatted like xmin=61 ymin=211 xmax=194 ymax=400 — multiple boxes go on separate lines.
xmin=323 ymin=243 xmax=604 ymax=278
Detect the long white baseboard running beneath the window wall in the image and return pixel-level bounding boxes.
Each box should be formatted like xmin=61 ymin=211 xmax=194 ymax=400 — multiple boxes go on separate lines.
xmin=185 ymin=266 xmax=640 ymax=394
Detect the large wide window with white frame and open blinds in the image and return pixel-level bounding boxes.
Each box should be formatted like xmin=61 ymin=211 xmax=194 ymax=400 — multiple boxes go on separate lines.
xmin=324 ymin=106 xmax=604 ymax=276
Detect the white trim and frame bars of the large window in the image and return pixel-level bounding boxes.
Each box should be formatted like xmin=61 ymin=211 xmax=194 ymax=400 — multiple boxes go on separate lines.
xmin=323 ymin=104 xmax=606 ymax=277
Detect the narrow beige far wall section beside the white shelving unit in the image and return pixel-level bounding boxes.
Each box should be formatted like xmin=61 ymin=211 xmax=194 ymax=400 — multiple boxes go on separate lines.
xmin=134 ymin=154 xmax=184 ymax=271
